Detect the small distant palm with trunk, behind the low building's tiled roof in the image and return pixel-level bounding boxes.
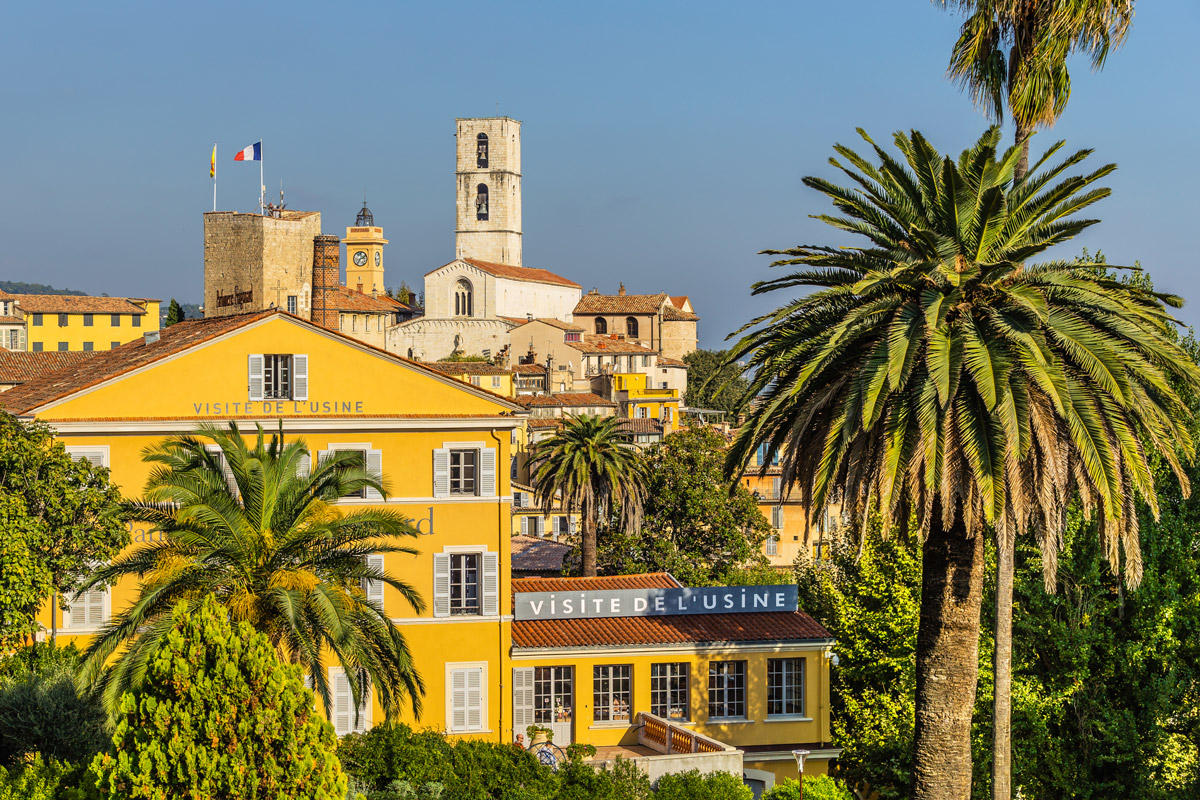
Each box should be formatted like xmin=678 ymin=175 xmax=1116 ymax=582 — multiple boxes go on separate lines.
xmin=529 ymin=414 xmax=646 ymax=577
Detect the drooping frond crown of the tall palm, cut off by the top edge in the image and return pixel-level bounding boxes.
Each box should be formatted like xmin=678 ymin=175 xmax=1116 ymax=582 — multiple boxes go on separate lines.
xmin=936 ymin=0 xmax=1134 ymax=180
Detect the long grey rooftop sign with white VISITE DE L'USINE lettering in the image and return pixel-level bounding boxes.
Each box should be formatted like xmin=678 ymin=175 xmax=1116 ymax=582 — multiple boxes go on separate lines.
xmin=514 ymin=584 xmax=799 ymax=620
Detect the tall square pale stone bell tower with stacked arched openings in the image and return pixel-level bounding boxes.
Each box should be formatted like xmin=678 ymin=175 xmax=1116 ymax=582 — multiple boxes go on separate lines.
xmin=455 ymin=116 xmax=522 ymax=266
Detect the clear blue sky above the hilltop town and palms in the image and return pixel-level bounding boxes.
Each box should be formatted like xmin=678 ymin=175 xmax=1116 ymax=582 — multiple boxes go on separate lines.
xmin=0 ymin=0 xmax=1200 ymax=347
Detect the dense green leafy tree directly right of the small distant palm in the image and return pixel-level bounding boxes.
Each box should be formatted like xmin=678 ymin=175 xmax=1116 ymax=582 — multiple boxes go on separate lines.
xmin=598 ymin=427 xmax=770 ymax=587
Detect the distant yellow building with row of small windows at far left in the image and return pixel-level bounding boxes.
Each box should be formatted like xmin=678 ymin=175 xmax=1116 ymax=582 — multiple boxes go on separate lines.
xmin=0 ymin=291 xmax=160 ymax=351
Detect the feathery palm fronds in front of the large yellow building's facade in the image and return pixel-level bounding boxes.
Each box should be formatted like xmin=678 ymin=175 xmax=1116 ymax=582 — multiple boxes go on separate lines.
xmin=80 ymin=423 xmax=425 ymax=717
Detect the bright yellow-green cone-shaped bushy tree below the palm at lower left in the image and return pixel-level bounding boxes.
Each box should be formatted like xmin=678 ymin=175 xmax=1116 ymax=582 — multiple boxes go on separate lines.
xmin=92 ymin=596 xmax=346 ymax=800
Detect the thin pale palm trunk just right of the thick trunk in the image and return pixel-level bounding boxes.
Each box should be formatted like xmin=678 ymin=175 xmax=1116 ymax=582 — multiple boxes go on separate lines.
xmin=991 ymin=531 xmax=1015 ymax=800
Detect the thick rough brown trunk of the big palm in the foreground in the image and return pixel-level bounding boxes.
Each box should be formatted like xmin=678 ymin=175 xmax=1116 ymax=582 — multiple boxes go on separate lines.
xmin=912 ymin=504 xmax=984 ymax=800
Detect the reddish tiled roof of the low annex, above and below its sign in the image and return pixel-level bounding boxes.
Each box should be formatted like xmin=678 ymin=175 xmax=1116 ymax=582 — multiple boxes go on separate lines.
xmin=511 ymin=572 xmax=833 ymax=648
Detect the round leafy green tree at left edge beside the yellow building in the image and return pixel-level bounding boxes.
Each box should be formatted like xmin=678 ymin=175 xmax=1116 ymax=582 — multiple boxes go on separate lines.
xmin=0 ymin=411 xmax=130 ymax=638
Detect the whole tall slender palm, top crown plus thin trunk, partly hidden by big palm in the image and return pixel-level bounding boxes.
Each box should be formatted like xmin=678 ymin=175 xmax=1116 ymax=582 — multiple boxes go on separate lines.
xmin=941 ymin=6 xmax=1133 ymax=800
